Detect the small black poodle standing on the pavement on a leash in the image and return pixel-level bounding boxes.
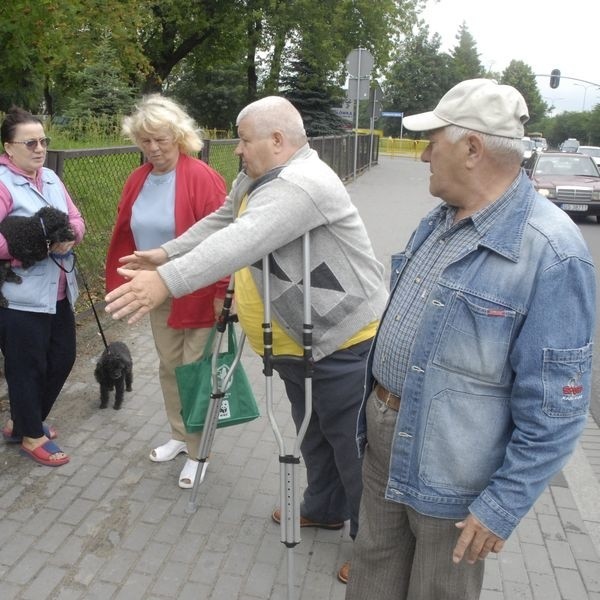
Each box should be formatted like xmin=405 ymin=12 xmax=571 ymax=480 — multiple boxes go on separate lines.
xmin=94 ymin=342 xmax=133 ymax=410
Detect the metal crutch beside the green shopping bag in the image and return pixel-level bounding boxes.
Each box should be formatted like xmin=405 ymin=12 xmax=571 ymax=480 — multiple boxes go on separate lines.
xmin=186 ymin=288 xmax=246 ymax=513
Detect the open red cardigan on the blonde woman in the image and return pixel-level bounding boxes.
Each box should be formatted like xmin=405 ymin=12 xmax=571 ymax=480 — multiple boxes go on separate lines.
xmin=105 ymin=154 xmax=229 ymax=329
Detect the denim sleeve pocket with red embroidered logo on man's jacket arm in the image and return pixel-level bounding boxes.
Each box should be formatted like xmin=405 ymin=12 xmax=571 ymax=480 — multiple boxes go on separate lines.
xmin=542 ymin=344 xmax=592 ymax=417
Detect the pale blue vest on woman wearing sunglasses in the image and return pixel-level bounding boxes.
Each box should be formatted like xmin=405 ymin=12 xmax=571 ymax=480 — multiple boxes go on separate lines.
xmin=0 ymin=165 xmax=79 ymax=314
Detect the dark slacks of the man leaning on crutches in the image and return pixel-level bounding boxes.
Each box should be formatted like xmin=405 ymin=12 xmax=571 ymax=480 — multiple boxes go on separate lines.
xmin=275 ymin=340 xmax=372 ymax=538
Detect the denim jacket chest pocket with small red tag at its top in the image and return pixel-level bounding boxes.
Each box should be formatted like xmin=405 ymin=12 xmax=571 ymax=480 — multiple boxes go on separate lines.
xmin=432 ymin=293 xmax=517 ymax=384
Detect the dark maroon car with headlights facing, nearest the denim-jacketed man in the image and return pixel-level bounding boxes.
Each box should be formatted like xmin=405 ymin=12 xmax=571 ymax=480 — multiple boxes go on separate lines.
xmin=523 ymin=152 xmax=600 ymax=223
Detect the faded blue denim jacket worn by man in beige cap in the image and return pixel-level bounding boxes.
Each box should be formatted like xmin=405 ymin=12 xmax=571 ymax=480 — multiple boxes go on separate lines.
xmin=357 ymin=174 xmax=595 ymax=539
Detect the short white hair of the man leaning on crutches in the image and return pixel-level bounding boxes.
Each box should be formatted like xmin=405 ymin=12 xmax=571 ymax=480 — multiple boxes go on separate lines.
xmin=235 ymin=96 xmax=306 ymax=146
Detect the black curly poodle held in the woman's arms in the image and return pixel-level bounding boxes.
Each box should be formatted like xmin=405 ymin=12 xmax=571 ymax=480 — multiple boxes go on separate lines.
xmin=0 ymin=206 xmax=75 ymax=308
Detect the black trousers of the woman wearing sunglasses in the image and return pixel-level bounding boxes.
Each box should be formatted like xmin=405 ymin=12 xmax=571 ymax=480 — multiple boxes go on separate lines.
xmin=0 ymin=298 xmax=75 ymax=438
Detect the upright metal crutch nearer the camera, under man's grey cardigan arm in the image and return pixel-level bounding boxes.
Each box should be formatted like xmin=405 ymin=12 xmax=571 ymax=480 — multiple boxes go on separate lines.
xmin=262 ymin=232 xmax=313 ymax=600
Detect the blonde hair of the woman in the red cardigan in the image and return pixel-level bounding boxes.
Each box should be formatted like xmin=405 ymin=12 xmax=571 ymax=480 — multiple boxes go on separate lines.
xmin=123 ymin=94 xmax=204 ymax=154
